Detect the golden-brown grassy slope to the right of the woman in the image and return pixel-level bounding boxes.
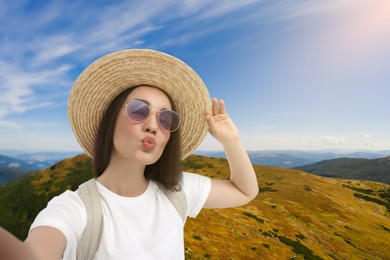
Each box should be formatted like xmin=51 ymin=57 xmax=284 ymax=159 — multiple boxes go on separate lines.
xmin=186 ymin=157 xmax=390 ymax=259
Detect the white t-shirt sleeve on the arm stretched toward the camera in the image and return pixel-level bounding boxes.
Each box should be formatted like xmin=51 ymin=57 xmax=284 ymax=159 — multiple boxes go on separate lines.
xmin=30 ymin=191 xmax=87 ymax=258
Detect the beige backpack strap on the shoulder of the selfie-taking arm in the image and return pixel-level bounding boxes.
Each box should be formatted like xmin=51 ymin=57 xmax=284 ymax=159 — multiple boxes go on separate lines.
xmin=77 ymin=178 xmax=103 ymax=260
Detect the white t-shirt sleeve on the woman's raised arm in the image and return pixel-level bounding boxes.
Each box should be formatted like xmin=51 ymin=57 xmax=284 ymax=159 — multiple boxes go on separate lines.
xmin=183 ymin=172 xmax=211 ymax=218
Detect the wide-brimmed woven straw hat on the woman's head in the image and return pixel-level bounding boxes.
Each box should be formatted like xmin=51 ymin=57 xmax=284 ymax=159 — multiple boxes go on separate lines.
xmin=68 ymin=49 xmax=211 ymax=159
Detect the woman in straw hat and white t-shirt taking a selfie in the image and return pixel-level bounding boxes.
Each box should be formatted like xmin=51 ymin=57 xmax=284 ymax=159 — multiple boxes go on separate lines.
xmin=3 ymin=50 xmax=258 ymax=259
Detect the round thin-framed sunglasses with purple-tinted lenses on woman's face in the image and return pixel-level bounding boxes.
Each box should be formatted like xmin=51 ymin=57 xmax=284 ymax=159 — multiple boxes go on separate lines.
xmin=125 ymin=99 xmax=180 ymax=132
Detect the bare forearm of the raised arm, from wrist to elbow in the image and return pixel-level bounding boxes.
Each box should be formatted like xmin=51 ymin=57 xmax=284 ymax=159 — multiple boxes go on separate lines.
xmin=223 ymin=140 xmax=259 ymax=199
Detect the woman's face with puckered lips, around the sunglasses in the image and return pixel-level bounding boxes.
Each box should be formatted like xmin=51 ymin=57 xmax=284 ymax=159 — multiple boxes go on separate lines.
xmin=112 ymin=86 xmax=172 ymax=165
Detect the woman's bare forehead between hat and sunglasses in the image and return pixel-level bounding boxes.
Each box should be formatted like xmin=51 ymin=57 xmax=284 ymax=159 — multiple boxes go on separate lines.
xmin=126 ymin=86 xmax=172 ymax=109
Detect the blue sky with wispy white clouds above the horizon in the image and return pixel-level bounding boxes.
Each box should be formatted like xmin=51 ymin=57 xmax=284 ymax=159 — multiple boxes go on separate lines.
xmin=0 ymin=0 xmax=390 ymax=151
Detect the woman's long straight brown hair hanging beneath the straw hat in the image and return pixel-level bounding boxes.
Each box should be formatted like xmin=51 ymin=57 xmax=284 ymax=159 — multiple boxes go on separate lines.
xmin=93 ymin=87 xmax=182 ymax=190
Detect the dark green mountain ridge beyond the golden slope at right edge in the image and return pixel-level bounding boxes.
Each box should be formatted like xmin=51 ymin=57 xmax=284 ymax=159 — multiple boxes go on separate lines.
xmin=295 ymin=156 xmax=390 ymax=184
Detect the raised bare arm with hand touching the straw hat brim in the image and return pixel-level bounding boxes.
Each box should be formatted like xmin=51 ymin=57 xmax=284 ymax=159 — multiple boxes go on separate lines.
xmin=205 ymin=98 xmax=259 ymax=208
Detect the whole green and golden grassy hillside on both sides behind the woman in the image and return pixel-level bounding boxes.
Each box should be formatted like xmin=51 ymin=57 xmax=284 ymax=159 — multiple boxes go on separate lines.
xmin=0 ymin=155 xmax=390 ymax=259
